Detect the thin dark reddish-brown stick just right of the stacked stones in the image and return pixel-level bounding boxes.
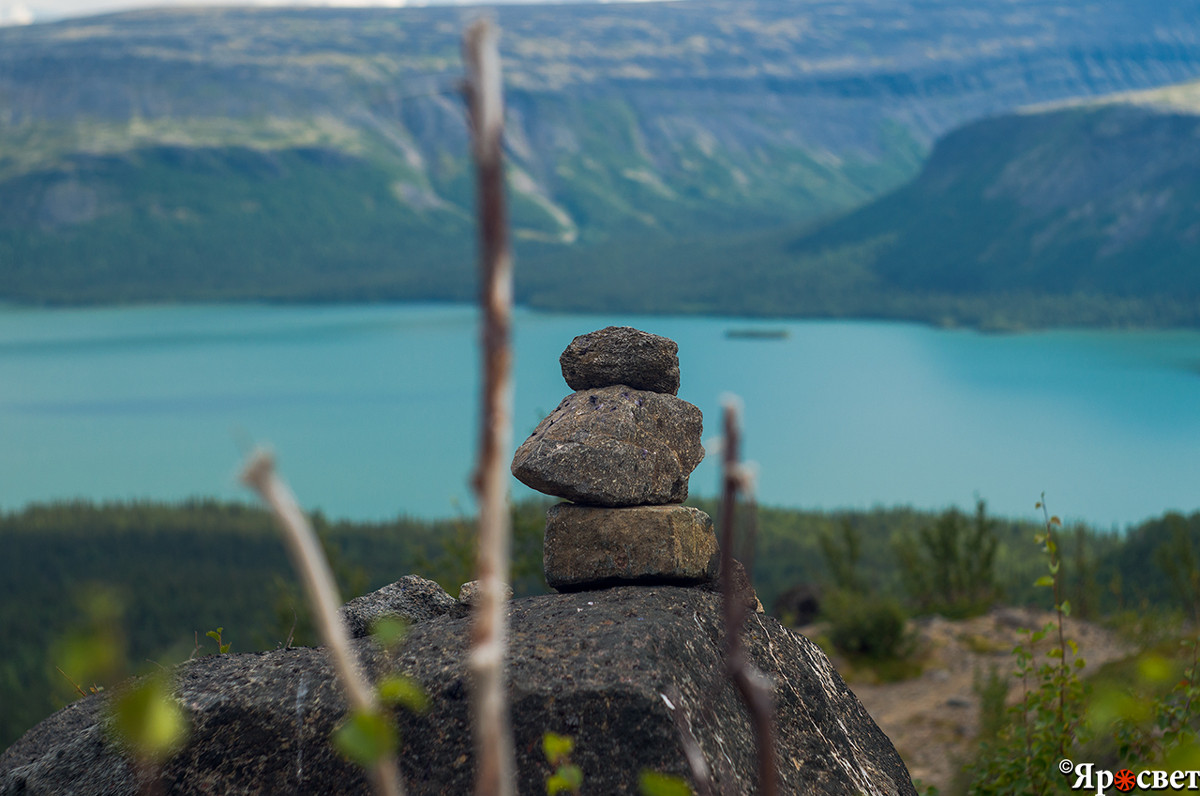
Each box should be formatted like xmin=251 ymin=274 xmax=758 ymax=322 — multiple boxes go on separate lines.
xmin=721 ymin=401 xmax=779 ymax=796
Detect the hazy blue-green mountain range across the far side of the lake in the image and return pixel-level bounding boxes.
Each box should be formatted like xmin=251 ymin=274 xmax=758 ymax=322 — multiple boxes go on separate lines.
xmin=7 ymin=0 xmax=1200 ymax=327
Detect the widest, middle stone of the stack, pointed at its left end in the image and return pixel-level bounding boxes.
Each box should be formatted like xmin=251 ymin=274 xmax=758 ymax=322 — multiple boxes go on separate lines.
xmin=512 ymin=385 xmax=704 ymax=507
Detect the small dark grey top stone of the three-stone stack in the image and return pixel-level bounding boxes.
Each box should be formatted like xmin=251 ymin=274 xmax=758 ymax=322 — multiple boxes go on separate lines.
xmin=558 ymin=327 xmax=679 ymax=395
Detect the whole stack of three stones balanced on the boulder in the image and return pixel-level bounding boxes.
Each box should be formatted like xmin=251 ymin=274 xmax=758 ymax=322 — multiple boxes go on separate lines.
xmin=512 ymin=327 xmax=719 ymax=591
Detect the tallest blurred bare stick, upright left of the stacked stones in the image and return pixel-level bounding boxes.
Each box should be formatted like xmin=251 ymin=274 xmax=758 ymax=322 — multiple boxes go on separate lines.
xmin=462 ymin=19 xmax=515 ymax=796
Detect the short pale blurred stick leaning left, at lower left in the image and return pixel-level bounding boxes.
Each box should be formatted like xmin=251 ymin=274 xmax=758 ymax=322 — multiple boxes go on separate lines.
xmin=241 ymin=450 xmax=404 ymax=796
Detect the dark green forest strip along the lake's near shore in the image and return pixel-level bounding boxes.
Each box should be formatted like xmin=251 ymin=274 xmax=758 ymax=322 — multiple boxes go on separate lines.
xmin=0 ymin=501 xmax=1200 ymax=768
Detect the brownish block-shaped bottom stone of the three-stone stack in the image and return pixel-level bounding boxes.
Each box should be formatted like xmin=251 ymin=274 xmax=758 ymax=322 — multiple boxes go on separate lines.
xmin=542 ymin=503 xmax=720 ymax=592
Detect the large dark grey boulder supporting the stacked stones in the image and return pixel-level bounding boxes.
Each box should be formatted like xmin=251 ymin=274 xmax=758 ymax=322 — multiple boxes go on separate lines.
xmin=0 ymin=586 xmax=916 ymax=796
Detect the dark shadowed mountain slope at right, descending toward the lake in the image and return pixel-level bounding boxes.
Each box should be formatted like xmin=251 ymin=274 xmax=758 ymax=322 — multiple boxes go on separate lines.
xmin=787 ymin=91 xmax=1200 ymax=323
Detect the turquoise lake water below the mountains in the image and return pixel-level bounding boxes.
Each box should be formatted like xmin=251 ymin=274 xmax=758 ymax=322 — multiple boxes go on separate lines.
xmin=0 ymin=305 xmax=1200 ymax=527
